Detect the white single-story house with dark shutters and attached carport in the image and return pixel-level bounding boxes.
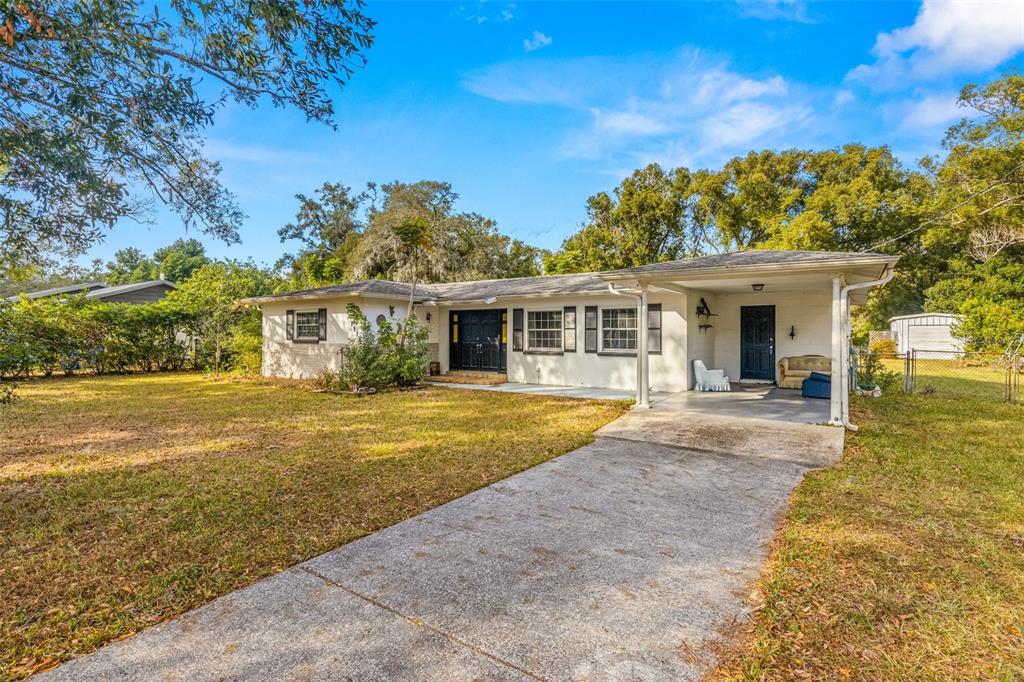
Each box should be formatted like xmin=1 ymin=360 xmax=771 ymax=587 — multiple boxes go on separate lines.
xmin=242 ymin=250 xmax=898 ymax=425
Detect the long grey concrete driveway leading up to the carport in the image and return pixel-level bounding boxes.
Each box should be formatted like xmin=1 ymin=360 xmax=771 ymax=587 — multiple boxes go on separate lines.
xmin=42 ymin=401 xmax=842 ymax=680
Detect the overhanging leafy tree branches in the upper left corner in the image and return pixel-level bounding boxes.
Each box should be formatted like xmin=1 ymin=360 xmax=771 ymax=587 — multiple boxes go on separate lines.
xmin=0 ymin=0 xmax=374 ymax=271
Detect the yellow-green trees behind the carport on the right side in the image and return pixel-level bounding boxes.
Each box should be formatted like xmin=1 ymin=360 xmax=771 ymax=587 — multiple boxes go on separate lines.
xmin=545 ymin=74 xmax=1024 ymax=347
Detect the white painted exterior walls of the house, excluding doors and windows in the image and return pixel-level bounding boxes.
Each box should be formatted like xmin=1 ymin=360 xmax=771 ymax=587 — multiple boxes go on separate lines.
xmin=262 ymin=290 xmax=831 ymax=391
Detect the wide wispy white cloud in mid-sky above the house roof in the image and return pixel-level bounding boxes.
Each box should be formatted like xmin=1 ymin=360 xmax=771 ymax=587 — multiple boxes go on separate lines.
xmin=463 ymin=49 xmax=815 ymax=167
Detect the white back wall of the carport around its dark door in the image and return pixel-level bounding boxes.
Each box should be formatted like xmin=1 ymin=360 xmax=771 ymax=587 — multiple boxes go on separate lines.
xmin=709 ymin=288 xmax=831 ymax=381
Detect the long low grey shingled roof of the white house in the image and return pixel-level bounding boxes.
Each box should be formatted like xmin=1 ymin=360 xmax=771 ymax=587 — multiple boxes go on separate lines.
xmin=240 ymin=251 xmax=899 ymax=304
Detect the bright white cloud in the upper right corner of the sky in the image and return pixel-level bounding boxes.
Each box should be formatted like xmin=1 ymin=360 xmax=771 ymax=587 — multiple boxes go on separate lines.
xmin=847 ymin=0 xmax=1024 ymax=88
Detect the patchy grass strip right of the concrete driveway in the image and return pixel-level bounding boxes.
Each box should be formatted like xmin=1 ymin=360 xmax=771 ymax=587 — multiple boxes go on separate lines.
xmin=718 ymin=395 xmax=1024 ymax=680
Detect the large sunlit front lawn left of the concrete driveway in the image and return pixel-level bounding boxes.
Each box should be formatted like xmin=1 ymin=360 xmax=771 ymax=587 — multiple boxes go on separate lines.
xmin=0 ymin=374 xmax=627 ymax=679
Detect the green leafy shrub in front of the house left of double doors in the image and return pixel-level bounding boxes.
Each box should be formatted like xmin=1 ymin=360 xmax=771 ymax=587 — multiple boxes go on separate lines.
xmin=341 ymin=304 xmax=429 ymax=388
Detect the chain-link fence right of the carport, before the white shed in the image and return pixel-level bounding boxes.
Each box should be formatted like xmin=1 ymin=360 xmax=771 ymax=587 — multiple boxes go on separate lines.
xmin=850 ymin=350 xmax=1024 ymax=403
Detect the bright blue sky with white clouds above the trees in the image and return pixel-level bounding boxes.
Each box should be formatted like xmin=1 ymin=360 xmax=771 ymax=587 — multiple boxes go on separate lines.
xmin=83 ymin=0 xmax=1024 ymax=263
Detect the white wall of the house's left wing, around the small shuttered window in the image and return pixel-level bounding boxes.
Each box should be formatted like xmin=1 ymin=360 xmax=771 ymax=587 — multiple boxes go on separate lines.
xmin=261 ymin=297 xmax=438 ymax=379
